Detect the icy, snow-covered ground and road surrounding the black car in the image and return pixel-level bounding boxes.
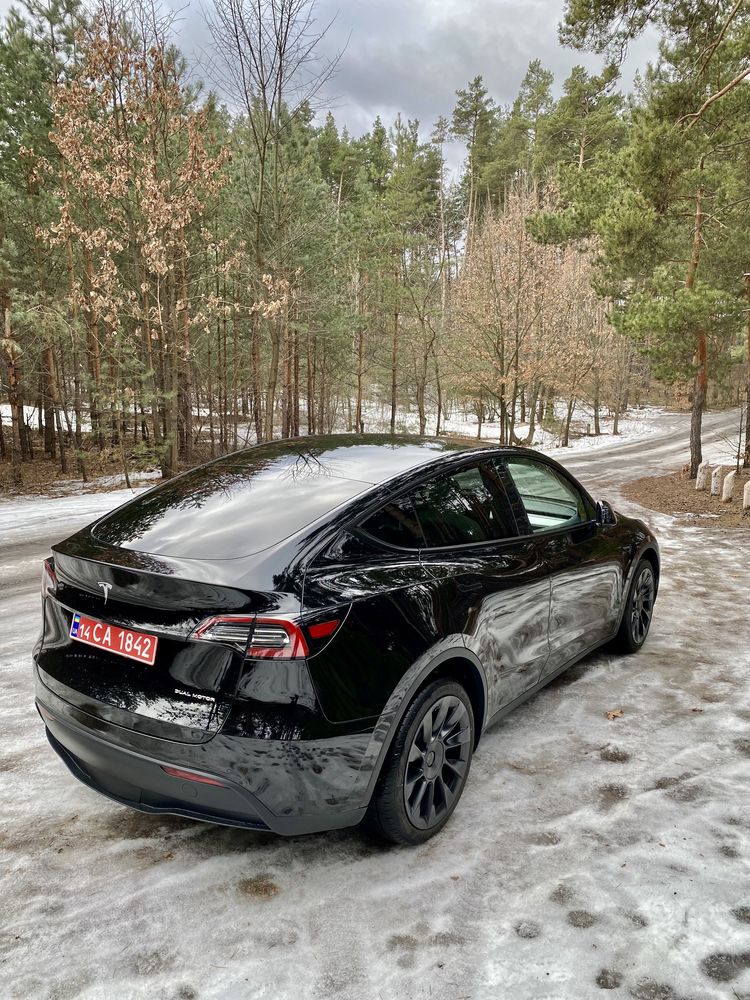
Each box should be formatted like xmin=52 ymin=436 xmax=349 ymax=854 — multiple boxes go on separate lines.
xmin=0 ymin=406 xmax=750 ymax=1000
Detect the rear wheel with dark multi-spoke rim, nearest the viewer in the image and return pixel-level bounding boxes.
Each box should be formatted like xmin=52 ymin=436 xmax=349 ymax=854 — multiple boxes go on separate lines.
xmin=365 ymin=678 xmax=474 ymax=844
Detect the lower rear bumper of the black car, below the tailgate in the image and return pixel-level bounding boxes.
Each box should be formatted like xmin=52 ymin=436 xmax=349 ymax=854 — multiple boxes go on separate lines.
xmin=36 ymin=675 xmax=371 ymax=836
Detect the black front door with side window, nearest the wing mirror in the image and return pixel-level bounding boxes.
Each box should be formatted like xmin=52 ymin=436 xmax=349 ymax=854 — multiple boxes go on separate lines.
xmin=504 ymin=455 xmax=623 ymax=679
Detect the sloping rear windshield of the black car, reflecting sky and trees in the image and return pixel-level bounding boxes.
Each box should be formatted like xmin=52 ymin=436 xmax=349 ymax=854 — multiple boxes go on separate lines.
xmin=93 ymin=447 xmax=370 ymax=559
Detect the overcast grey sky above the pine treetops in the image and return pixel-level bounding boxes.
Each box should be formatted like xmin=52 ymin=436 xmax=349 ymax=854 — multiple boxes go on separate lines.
xmin=0 ymin=0 xmax=656 ymax=145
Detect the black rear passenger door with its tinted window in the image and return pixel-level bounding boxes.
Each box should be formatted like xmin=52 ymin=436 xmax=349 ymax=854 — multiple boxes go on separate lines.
xmin=412 ymin=459 xmax=550 ymax=718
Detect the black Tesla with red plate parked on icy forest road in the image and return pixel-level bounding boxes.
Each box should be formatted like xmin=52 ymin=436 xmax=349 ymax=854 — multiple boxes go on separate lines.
xmin=34 ymin=435 xmax=659 ymax=844
